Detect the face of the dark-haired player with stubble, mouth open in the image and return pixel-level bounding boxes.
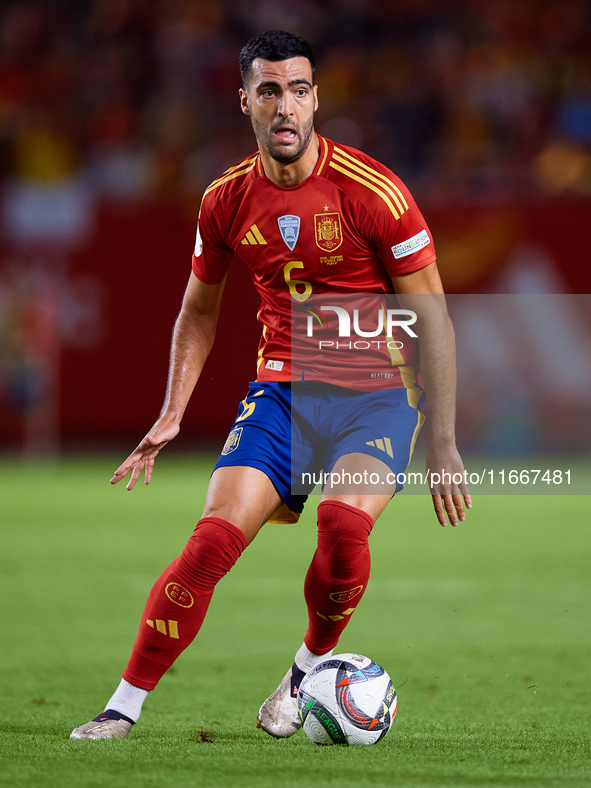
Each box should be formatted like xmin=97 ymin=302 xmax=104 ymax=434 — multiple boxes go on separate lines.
xmin=240 ymin=57 xmax=318 ymax=164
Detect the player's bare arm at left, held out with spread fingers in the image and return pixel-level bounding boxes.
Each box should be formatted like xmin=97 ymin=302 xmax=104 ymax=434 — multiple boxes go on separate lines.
xmin=111 ymin=273 xmax=225 ymax=490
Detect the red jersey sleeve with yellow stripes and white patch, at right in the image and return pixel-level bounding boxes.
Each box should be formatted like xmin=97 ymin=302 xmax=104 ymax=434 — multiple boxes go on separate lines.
xmin=373 ymin=173 xmax=436 ymax=276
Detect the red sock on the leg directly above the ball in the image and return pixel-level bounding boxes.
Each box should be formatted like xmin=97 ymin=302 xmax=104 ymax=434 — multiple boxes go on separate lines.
xmin=304 ymin=501 xmax=373 ymax=654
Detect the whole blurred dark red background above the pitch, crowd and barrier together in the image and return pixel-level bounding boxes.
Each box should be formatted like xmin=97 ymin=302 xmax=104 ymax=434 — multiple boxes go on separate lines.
xmin=0 ymin=0 xmax=591 ymax=456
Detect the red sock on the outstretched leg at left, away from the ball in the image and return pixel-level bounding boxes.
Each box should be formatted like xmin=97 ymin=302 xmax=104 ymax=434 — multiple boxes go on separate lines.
xmin=123 ymin=517 xmax=246 ymax=690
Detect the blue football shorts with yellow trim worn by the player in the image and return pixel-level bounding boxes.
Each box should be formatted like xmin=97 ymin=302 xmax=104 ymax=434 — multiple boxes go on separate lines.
xmin=214 ymin=382 xmax=424 ymax=522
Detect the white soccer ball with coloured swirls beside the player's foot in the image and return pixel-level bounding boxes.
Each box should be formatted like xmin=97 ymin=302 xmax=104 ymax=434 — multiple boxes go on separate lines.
xmin=298 ymin=654 xmax=397 ymax=744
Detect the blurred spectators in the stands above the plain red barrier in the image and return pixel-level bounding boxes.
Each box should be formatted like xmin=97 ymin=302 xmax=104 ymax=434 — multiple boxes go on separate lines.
xmin=0 ymin=0 xmax=591 ymax=222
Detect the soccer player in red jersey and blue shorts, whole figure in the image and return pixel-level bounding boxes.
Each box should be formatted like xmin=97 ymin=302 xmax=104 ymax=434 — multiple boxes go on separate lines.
xmin=71 ymin=31 xmax=471 ymax=739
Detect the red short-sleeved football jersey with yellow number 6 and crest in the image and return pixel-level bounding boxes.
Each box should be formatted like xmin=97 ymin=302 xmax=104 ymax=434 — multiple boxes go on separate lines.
xmin=193 ymin=136 xmax=435 ymax=390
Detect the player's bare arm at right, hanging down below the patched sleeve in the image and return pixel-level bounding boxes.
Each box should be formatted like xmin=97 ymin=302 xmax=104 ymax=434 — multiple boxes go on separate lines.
xmin=392 ymin=263 xmax=472 ymax=526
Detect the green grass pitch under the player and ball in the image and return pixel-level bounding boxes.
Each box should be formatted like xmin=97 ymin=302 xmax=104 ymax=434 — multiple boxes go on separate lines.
xmin=0 ymin=455 xmax=591 ymax=788
